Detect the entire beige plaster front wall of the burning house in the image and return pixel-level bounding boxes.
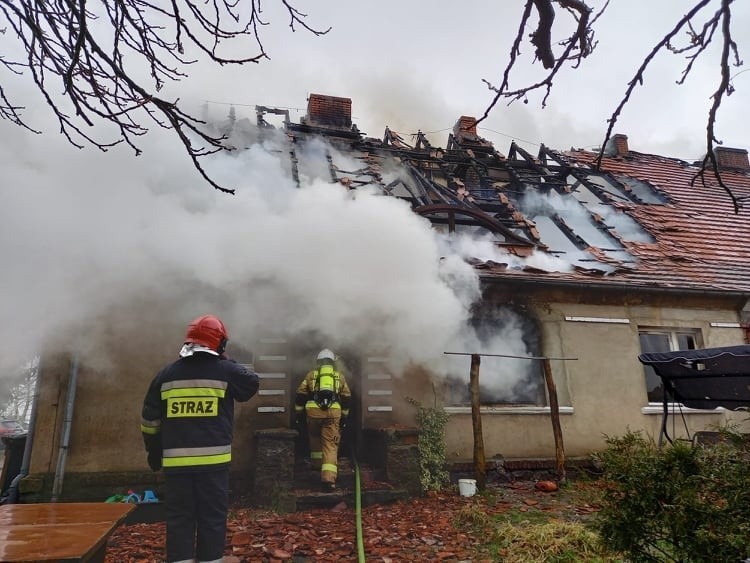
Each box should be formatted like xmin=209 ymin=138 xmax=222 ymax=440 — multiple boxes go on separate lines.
xmin=22 ymin=291 xmax=750 ymax=498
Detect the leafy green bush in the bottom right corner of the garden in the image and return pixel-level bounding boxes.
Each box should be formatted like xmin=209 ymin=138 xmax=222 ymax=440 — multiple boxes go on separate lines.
xmin=595 ymin=431 xmax=750 ymax=562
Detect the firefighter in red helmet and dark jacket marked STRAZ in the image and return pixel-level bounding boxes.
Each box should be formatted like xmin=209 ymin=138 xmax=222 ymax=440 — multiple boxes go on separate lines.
xmin=141 ymin=315 xmax=258 ymax=562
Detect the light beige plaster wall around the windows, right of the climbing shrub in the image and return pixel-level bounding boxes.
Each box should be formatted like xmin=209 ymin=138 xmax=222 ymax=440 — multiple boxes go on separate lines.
xmin=446 ymin=295 xmax=750 ymax=460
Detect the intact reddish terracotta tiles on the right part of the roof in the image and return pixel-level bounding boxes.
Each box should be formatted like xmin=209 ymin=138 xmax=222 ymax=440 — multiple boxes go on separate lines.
xmin=482 ymin=145 xmax=750 ymax=292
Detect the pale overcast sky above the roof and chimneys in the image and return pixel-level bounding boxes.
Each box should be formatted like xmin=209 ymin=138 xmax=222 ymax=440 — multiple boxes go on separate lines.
xmin=170 ymin=0 xmax=750 ymax=160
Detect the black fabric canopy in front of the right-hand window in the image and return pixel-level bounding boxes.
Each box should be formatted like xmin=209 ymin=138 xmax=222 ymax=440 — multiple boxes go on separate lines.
xmin=638 ymin=345 xmax=750 ymax=410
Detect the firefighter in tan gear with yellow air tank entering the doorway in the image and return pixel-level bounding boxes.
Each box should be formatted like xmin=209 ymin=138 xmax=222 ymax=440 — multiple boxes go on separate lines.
xmin=294 ymin=348 xmax=352 ymax=491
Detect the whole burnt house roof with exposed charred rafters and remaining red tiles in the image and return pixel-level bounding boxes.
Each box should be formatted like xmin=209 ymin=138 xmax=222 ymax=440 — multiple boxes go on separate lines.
xmin=256 ymin=94 xmax=750 ymax=293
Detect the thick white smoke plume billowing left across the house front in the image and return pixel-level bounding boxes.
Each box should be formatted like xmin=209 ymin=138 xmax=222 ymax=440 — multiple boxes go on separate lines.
xmin=0 ymin=109 xmax=464 ymax=374
